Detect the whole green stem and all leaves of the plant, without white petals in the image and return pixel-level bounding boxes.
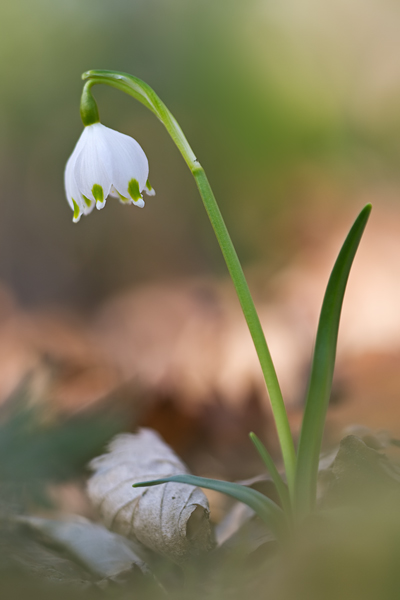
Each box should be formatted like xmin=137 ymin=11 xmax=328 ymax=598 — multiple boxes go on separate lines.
xmin=77 ymin=70 xmax=371 ymax=538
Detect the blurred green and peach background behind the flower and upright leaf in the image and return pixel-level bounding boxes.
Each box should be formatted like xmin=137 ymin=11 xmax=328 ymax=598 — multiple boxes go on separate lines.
xmin=0 ymin=0 xmax=400 ymax=510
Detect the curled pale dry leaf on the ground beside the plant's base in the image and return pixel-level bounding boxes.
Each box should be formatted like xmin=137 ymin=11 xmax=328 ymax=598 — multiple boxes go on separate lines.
xmin=88 ymin=428 xmax=213 ymax=563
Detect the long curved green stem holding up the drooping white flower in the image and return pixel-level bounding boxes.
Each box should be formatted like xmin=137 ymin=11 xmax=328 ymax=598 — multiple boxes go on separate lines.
xmin=82 ymin=70 xmax=296 ymax=494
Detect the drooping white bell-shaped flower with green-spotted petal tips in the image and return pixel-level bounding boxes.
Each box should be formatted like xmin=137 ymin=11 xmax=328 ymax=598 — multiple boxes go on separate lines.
xmin=64 ymin=123 xmax=155 ymax=223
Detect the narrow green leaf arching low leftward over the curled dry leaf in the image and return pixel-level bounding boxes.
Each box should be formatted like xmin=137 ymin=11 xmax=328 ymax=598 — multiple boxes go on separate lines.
xmin=132 ymin=475 xmax=286 ymax=538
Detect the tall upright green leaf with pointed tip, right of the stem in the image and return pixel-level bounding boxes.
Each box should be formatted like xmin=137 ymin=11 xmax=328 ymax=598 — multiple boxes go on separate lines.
xmin=295 ymin=204 xmax=371 ymax=515
